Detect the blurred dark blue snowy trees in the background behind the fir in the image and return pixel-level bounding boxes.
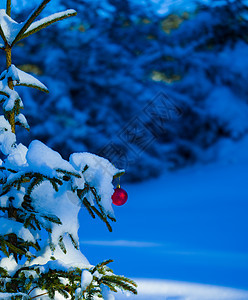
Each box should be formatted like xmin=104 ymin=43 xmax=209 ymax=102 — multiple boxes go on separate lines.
xmin=4 ymin=0 xmax=248 ymax=180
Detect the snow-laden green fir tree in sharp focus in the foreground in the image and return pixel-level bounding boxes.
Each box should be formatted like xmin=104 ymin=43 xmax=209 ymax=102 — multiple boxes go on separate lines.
xmin=0 ymin=0 xmax=136 ymax=300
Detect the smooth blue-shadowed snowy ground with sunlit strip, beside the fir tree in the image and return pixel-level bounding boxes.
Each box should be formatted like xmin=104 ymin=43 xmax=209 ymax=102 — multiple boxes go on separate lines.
xmin=79 ymin=141 xmax=248 ymax=300
